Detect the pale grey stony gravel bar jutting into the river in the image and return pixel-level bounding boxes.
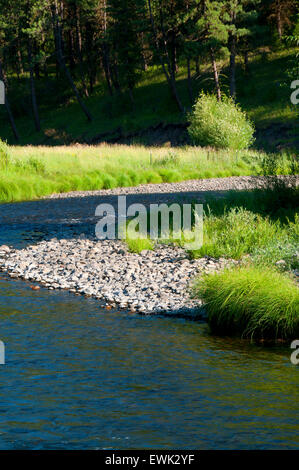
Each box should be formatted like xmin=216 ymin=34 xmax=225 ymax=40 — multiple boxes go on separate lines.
xmin=0 ymin=242 xmax=236 ymax=315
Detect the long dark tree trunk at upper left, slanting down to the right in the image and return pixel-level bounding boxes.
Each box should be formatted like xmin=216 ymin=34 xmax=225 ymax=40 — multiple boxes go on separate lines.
xmin=51 ymin=0 xmax=92 ymax=121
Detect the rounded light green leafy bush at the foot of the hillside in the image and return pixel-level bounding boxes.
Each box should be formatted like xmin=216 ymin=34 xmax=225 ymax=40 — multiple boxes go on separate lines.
xmin=188 ymin=93 xmax=254 ymax=150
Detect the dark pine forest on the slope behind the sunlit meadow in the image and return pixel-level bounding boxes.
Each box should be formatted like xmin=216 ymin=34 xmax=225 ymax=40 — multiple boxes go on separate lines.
xmin=0 ymin=0 xmax=299 ymax=144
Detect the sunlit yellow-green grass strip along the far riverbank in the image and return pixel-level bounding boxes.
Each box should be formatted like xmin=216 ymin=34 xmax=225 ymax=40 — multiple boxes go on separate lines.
xmin=0 ymin=144 xmax=292 ymax=202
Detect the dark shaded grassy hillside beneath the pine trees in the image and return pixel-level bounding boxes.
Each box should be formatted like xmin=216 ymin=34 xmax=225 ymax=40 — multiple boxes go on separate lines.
xmin=0 ymin=48 xmax=298 ymax=151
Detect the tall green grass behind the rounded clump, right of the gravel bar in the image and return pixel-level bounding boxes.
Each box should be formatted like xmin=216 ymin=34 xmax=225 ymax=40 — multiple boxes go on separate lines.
xmin=191 ymin=207 xmax=299 ymax=268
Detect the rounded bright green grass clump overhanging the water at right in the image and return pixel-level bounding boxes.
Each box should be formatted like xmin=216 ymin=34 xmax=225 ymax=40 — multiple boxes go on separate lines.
xmin=194 ymin=267 xmax=299 ymax=340
